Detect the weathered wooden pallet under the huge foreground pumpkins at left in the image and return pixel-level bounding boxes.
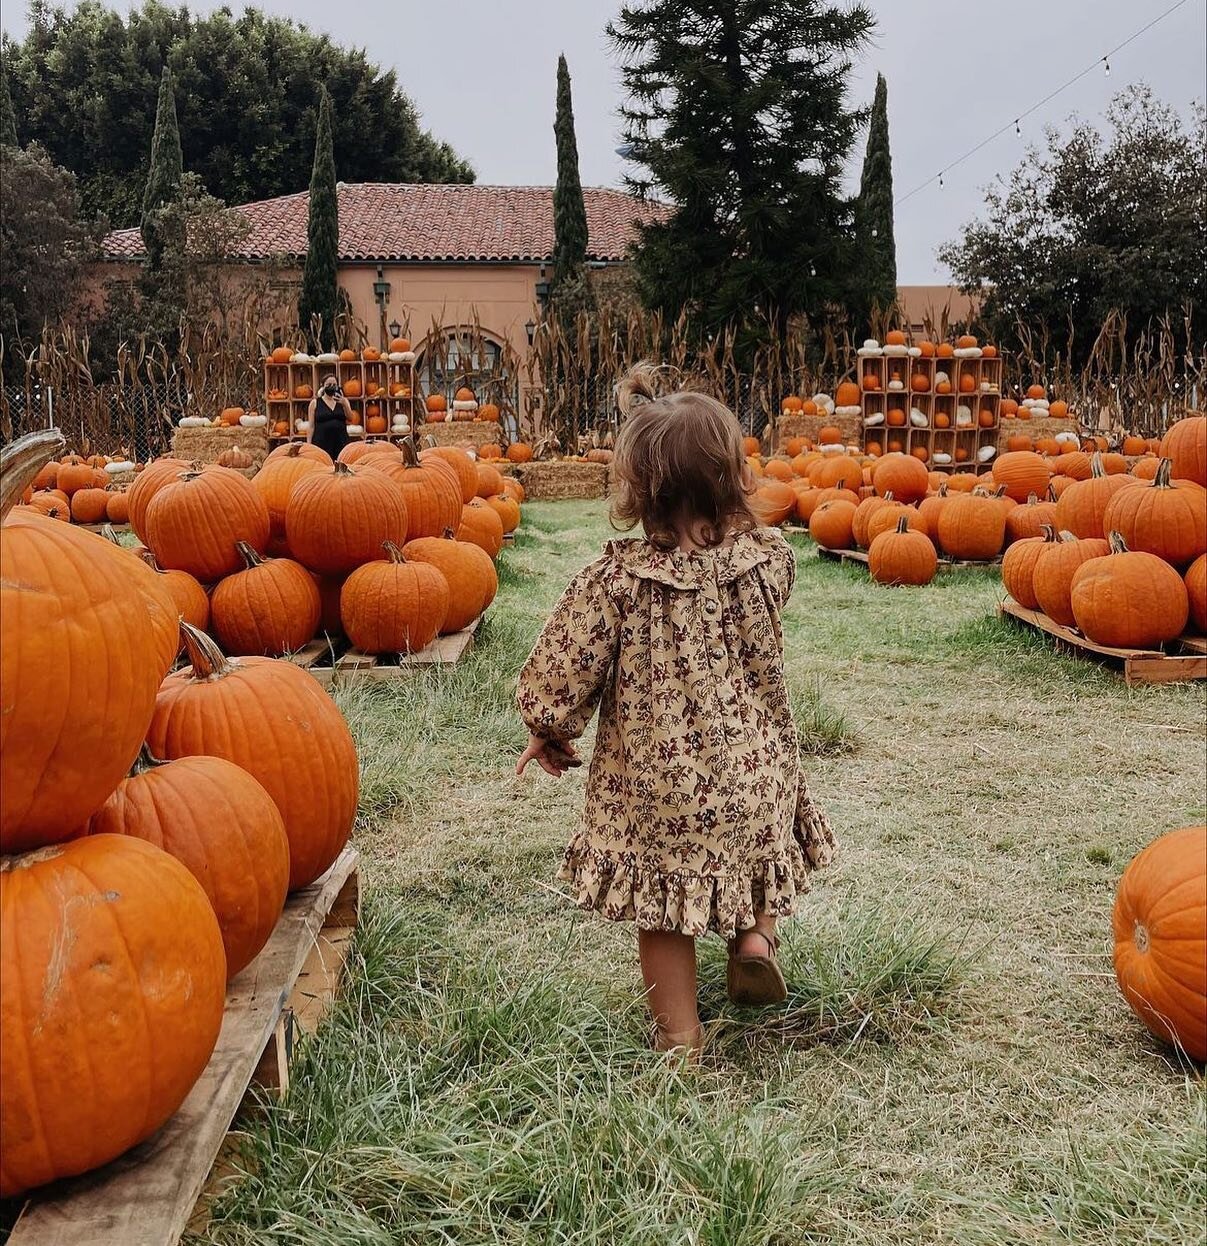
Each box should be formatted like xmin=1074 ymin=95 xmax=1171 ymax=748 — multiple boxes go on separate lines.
xmin=9 ymin=849 xmax=360 ymax=1246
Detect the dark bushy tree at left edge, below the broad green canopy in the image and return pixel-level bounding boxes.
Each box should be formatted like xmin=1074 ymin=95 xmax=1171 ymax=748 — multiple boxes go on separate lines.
xmin=0 ymin=143 xmax=98 ymax=341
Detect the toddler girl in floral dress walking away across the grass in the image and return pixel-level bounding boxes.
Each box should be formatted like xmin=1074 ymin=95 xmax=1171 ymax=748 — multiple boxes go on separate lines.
xmin=517 ymin=365 xmax=833 ymax=1053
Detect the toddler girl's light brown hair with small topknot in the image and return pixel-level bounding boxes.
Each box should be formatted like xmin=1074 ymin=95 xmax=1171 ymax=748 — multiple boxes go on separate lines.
xmin=612 ymin=364 xmax=759 ymax=549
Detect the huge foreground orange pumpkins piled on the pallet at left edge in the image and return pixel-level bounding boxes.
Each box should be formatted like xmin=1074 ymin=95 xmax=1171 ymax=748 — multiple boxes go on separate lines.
xmin=0 ymin=431 xmax=359 ymax=1197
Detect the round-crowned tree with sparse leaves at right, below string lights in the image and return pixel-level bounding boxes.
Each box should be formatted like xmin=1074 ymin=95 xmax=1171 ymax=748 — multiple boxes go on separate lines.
xmin=939 ymin=85 xmax=1207 ymax=366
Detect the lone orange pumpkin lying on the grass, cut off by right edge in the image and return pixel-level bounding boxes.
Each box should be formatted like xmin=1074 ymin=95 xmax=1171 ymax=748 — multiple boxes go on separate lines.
xmin=1112 ymin=826 xmax=1207 ymax=1063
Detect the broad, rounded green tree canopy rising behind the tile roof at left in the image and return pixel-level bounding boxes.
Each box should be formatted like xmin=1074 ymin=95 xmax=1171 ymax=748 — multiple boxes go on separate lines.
xmin=5 ymin=0 xmax=473 ymax=226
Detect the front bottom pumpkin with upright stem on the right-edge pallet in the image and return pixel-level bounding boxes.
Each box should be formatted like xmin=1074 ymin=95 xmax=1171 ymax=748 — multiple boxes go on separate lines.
xmin=1069 ymin=532 xmax=1190 ymax=649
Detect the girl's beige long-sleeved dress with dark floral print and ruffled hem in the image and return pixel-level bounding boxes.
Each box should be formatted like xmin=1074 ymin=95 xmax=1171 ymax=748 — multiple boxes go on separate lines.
xmin=518 ymin=528 xmax=833 ymax=937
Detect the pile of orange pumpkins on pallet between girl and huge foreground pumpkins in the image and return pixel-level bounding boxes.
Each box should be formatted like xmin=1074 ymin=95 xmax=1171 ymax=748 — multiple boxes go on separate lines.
xmin=130 ymin=440 xmax=523 ymax=657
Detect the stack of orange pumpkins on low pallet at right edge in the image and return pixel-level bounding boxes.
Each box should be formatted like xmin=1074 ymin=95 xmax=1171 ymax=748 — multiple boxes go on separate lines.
xmin=1001 ymin=415 xmax=1207 ymax=649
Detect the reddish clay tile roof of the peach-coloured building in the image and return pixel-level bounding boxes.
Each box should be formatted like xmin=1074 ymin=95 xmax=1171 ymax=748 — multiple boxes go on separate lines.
xmin=103 ymin=182 xmax=669 ymax=263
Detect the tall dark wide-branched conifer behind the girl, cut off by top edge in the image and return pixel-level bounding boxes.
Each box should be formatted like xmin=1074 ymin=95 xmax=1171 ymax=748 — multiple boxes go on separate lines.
xmin=608 ymin=0 xmax=873 ymax=358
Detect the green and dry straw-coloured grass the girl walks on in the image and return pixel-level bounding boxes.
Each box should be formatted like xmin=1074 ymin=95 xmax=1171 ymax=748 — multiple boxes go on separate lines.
xmin=183 ymin=503 xmax=1207 ymax=1246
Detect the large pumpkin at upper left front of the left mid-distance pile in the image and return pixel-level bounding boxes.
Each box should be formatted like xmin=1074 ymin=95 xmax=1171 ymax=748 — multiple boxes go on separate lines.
xmin=146 ymin=467 xmax=269 ymax=584
